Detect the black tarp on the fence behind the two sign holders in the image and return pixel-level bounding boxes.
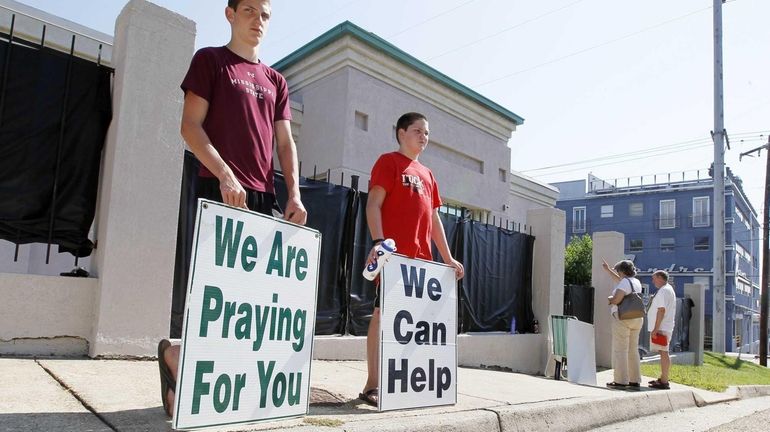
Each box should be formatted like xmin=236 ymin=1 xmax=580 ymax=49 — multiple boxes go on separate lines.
xmin=171 ymin=155 xmax=534 ymax=337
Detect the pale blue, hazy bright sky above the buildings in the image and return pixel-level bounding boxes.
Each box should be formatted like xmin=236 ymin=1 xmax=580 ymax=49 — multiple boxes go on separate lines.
xmin=10 ymin=0 xmax=770 ymax=220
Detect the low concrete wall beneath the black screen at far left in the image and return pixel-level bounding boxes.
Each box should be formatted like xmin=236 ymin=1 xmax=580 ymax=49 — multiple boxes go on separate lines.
xmin=0 ymin=273 xmax=97 ymax=355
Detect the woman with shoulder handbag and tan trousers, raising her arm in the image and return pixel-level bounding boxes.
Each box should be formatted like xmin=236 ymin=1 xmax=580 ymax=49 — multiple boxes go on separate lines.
xmin=602 ymin=260 xmax=644 ymax=390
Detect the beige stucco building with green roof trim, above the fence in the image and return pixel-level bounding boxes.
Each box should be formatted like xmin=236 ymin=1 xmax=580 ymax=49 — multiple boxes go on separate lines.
xmin=273 ymin=21 xmax=558 ymax=223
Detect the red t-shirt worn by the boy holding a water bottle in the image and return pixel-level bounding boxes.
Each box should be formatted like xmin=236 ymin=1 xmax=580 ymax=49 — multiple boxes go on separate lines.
xmin=369 ymin=152 xmax=441 ymax=260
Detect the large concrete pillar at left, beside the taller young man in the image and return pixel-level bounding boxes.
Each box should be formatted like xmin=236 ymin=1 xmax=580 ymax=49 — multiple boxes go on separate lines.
xmin=89 ymin=0 xmax=195 ymax=356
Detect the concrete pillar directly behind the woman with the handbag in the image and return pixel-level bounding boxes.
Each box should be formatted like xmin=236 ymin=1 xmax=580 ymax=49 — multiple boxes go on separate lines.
xmin=591 ymin=232 xmax=625 ymax=368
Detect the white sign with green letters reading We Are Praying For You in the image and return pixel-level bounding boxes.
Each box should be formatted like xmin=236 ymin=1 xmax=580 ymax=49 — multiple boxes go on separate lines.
xmin=173 ymin=200 xmax=321 ymax=429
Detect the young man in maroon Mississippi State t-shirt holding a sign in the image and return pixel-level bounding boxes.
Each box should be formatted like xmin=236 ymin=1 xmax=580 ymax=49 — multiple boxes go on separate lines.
xmin=158 ymin=0 xmax=307 ymax=417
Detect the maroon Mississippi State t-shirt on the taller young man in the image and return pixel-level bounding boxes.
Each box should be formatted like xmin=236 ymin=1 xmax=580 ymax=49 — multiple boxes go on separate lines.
xmin=182 ymin=47 xmax=291 ymax=192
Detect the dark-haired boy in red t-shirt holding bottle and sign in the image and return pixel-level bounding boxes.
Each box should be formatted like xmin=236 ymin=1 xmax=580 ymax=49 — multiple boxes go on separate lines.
xmin=359 ymin=113 xmax=465 ymax=406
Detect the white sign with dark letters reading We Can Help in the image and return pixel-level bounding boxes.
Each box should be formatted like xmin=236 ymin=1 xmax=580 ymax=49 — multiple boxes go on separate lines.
xmin=379 ymin=255 xmax=457 ymax=411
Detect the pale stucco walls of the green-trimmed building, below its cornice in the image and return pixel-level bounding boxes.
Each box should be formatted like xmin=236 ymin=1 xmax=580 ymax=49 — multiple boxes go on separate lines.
xmin=290 ymin=67 xmax=510 ymax=215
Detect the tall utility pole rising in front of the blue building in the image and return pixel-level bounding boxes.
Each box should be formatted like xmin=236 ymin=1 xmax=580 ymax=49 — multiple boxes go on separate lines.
xmin=711 ymin=0 xmax=725 ymax=353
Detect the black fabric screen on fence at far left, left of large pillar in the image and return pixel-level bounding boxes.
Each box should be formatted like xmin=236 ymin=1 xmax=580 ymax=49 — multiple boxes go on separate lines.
xmin=0 ymin=37 xmax=112 ymax=257
